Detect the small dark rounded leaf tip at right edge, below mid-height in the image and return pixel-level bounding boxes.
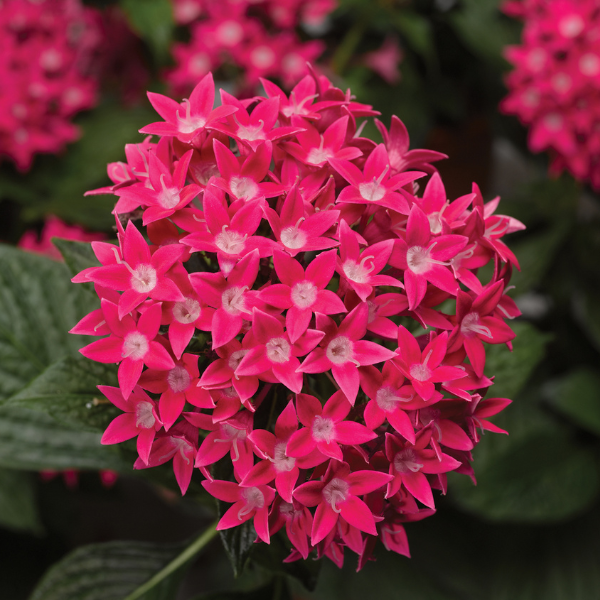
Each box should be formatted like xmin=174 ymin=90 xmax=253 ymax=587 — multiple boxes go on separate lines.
xmin=543 ymin=367 xmax=600 ymax=435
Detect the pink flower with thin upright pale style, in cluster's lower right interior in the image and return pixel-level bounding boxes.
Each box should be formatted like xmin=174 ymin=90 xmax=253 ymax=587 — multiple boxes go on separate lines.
xmin=394 ymin=325 xmax=465 ymax=400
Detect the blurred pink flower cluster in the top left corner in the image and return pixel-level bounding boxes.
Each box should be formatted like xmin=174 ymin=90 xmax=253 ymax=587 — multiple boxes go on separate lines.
xmin=0 ymin=0 xmax=101 ymax=171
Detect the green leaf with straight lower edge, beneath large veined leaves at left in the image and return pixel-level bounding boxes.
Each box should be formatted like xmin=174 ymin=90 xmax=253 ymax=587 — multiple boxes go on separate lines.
xmin=0 ymin=406 xmax=131 ymax=471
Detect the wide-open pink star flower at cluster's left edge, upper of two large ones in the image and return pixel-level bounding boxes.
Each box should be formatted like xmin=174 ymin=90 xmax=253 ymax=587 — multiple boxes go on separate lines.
xmin=87 ymin=221 xmax=184 ymax=319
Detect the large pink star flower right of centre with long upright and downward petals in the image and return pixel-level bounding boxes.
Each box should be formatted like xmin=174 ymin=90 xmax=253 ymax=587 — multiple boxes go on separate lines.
xmin=390 ymin=204 xmax=468 ymax=310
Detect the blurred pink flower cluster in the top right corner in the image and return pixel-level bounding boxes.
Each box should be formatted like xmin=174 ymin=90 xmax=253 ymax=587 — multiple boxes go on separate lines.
xmin=501 ymin=0 xmax=600 ymax=189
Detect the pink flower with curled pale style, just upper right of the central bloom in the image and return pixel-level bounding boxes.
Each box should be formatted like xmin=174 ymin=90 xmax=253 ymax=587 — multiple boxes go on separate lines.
xmin=336 ymin=221 xmax=404 ymax=302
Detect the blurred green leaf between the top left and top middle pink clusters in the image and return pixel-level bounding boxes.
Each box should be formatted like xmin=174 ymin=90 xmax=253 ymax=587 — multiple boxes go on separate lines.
xmin=121 ymin=0 xmax=175 ymax=62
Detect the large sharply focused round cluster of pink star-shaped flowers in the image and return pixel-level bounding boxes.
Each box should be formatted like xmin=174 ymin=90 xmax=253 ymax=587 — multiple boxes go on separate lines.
xmin=72 ymin=74 xmax=523 ymax=566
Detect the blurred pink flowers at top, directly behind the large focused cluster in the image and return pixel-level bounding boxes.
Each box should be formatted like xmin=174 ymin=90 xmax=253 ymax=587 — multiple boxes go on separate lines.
xmin=167 ymin=0 xmax=337 ymax=93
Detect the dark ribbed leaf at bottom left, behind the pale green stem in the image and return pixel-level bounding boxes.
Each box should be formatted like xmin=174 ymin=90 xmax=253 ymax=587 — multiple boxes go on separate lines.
xmin=29 ymin=542 xmax=188 ymax=600
